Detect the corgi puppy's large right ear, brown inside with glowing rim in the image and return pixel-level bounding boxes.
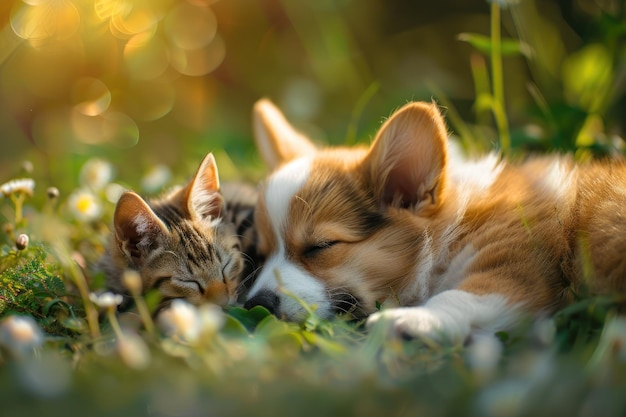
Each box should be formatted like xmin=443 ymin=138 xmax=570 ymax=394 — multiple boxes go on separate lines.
xmin=364 ymin=102 xmax=448 ymax=215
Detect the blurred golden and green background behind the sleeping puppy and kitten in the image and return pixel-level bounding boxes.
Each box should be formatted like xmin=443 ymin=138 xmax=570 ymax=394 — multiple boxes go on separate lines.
xmin=0 ymin=0 xmax=626 ymax=189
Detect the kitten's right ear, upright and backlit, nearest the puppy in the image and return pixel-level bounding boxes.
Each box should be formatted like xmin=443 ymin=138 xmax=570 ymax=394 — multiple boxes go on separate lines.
xmin=181 ymin=153 xmax=224 ymax=219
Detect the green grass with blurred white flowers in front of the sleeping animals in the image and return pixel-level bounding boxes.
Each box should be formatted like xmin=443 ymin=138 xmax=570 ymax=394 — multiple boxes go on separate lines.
xmin=0 ymin=177 xmax=626 ymax=416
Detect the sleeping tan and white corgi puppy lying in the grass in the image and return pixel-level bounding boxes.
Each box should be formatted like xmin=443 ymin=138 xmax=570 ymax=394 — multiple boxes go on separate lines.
xmin=246 ymin=100 xmax=626 ymax=342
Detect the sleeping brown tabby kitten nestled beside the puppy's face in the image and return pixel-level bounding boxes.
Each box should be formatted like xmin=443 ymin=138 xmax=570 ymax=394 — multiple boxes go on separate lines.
xmin=101 ymin=153 xmax=256 ymax=310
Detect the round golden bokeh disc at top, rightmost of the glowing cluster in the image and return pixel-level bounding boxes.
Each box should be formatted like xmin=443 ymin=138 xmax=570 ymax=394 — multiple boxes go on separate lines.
xmin=165 ymin=3 xmax=217 ymax=49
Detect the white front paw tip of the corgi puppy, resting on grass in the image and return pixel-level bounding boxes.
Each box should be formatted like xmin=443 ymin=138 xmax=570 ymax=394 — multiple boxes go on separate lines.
xmin=367 ymin=307 xmax=469 ymax=343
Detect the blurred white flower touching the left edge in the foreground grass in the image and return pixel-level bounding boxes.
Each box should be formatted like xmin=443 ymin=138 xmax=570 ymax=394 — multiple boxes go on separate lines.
xmin=0 ymin=316 xmax=44 ymax=356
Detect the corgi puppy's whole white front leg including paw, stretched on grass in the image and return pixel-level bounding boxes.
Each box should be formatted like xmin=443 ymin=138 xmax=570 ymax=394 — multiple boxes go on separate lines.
xmin=367 ymin=290 xmax=520 ymax=343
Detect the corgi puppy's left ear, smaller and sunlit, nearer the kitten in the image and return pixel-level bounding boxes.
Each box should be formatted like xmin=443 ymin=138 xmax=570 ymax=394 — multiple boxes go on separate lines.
xmin=252 ymin=99 xmax=316 ymax=170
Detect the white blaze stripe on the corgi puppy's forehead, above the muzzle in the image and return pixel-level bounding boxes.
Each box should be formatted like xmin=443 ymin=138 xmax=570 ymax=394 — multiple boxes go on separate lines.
xmin=265 ymin=158 xmax=311 ymax=236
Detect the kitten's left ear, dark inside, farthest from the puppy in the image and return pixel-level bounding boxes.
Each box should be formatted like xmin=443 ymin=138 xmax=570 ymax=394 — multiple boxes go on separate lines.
xmin=113 ymin=191 xmax=167 ymax=264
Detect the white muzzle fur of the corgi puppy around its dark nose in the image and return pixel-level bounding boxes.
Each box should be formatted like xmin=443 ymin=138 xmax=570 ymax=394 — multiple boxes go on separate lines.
xmin=248 ymin=248 xmax=332 ymax=321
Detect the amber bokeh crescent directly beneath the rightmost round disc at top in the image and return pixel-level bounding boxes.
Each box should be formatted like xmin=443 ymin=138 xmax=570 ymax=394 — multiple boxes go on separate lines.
xmin=171 ymin=36 xmax=226 ymax=76
